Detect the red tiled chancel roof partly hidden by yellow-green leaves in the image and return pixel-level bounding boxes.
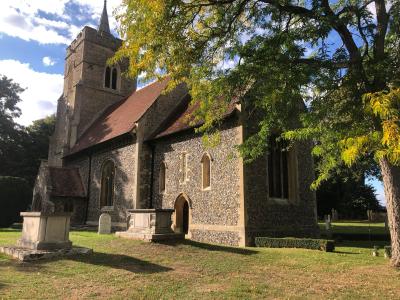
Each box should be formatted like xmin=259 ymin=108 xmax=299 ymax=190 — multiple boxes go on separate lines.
xmin=154 ymin=97 xmax=235 ymax=139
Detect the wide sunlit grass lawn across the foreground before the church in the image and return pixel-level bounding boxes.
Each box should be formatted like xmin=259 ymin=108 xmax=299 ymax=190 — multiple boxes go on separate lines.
xmin=0 ymin=229 xmax=400 ymax=299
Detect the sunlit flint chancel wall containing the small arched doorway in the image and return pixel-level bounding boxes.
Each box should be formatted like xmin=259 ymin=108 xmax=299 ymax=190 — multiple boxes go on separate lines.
xmin=153 ymin=118 xmax=240 ymax=245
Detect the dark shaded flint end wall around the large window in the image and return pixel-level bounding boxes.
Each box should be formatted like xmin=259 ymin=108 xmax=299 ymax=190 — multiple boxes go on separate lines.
xmin=244 ymin=106 xmax=319 ymax=245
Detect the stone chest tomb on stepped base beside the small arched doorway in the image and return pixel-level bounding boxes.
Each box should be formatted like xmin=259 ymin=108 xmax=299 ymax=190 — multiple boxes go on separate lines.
xmin=116 ymin=209 xmax=184 ymax=241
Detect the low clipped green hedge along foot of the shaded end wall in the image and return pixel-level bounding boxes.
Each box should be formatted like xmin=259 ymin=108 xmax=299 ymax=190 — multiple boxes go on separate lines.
xmin=255 ymin=237 xmax=335 ymax=252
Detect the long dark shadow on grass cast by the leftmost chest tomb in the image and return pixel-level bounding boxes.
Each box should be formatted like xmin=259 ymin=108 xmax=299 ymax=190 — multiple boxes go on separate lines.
xmin=69 ymin=252 xmax=173 ymax=274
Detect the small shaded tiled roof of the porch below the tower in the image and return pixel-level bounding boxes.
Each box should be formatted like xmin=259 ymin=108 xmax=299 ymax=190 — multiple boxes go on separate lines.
xmin=49 ymin=167 xmax=86 ymax=198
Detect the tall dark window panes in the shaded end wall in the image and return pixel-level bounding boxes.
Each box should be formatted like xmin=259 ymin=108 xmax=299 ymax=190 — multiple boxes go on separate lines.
xmin=268 ymin=136 xmax=289 ymax=199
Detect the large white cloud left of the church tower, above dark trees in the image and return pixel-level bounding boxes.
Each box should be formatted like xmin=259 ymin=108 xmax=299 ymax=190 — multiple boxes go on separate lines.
xmin=0 ymin=60 xmax=64 ymax=125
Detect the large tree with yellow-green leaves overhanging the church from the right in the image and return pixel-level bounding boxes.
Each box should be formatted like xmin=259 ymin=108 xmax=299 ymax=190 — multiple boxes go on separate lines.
xmin=110 ymin=0 xmax=400 ymax=266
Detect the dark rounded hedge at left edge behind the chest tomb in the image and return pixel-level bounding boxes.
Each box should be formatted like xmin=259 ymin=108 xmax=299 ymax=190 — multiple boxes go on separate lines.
xmin=0 ymin=176 xmax=32 ymax=227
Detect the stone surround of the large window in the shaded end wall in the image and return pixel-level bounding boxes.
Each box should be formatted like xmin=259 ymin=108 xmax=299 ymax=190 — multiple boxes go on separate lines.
xmin=266 ymin=136 xmax=299 ymax=204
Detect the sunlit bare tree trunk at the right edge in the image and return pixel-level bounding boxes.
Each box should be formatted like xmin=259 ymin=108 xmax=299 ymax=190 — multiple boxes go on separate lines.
xmin=379 ymin=158 xmax=400 ymax=267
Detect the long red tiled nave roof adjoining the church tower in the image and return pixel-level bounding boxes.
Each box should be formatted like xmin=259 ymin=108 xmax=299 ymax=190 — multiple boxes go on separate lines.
xmin=69 ymin=79 xmax=169 ymax=154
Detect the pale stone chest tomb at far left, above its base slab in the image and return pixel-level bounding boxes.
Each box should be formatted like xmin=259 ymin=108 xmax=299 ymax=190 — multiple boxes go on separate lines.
xmin=17 ymin=212 xmax=72 ymax=250
